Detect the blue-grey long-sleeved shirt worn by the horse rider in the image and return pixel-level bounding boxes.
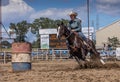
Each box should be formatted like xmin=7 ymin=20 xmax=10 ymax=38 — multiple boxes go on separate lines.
xmin=68 ymin=18 xmax=82 ymax=32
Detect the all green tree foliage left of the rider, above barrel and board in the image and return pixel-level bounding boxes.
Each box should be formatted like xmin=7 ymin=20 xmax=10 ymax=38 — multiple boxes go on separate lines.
xmin=9 ymin=17 xmax=68 ymax=47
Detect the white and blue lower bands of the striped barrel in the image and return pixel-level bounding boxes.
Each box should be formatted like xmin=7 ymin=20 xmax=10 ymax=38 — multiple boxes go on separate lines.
xmin=12 ymin=53 xmax=31 ymax=71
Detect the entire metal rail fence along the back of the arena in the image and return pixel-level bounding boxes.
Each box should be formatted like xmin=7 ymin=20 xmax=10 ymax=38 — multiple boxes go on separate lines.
xmin=0 ymin=49 xmax=116 ymax=64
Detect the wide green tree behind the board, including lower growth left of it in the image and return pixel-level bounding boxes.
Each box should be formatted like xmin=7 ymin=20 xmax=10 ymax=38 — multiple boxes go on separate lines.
xmin=30 ymin=17 xmax=68 ymax=46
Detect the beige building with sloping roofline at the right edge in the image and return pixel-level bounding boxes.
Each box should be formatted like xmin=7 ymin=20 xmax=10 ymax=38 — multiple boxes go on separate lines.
xmin=96 ymin=20 xmax=120 ymax=46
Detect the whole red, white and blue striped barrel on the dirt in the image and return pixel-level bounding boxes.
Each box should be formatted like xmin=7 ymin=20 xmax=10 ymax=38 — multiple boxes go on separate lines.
xmin=12 ymin=42 xmax=32 ymax=72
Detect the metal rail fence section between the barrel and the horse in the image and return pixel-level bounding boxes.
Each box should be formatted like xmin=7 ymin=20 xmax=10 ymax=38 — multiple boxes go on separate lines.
xmin=32 ymin=49 xmax=69 ymax=60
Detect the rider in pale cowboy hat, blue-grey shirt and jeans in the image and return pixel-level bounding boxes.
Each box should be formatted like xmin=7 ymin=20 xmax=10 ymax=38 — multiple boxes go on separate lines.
xmin=67 ymin=11 xmax=87 ymax=58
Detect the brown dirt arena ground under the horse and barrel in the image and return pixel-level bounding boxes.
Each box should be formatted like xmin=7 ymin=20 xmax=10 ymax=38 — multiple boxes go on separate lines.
xmin=0 ymin=60 xmax=120 ymax=82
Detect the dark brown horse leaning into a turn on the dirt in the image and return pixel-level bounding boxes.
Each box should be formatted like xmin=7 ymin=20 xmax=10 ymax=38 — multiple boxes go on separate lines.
xmin=57 ymin=22 xmax=103 ymax=66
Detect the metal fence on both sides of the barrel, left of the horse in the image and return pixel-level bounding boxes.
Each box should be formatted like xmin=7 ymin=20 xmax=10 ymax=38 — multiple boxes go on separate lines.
xmin=0 ymin=49 xmax=69 ymax=64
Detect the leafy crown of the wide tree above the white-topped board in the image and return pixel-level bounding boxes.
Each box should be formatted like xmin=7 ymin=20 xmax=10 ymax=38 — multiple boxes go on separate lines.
xmin=31 ymin=17 xmax=68 ymax=33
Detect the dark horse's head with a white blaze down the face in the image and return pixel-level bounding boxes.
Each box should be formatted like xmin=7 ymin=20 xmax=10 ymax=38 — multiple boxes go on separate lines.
xmin=57 ymin=22 xmax=65 ymax=40
